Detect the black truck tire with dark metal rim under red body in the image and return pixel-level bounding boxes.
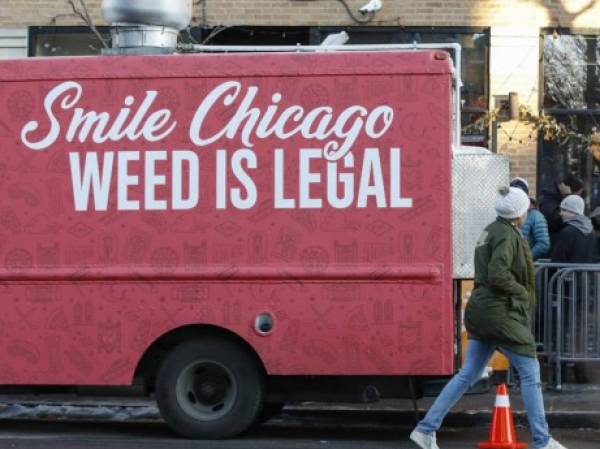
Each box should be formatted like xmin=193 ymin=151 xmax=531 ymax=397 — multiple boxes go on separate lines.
xmin=156 ymin=338 xmax=265 ymax=439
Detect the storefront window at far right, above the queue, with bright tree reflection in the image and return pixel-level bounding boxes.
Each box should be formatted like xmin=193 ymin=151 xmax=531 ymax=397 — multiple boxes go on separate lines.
xmin=538 ymin=30 xmax=600 ymax=207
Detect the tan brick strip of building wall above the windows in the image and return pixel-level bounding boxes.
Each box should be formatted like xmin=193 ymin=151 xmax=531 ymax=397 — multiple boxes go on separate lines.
xmin=0 ymin=0 xmax=600 ymax=28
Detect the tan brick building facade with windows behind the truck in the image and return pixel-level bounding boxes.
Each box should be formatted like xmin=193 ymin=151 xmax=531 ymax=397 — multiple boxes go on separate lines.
xmin=0 ymin=0 xmax=600 ymax=200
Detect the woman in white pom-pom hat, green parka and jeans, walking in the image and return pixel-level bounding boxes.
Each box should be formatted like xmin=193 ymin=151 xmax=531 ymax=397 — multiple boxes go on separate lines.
xmin=410 ymin=187 xmax=566 ymax=449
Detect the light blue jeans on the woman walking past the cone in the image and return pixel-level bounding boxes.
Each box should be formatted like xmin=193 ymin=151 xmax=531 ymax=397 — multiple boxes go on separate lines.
xmin=417 ymin=340 xmax=550 ymax=449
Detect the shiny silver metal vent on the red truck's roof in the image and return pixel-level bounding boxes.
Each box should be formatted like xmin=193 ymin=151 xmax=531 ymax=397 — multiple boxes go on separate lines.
xmin=102 ymin=0 xmax=192 ymax=55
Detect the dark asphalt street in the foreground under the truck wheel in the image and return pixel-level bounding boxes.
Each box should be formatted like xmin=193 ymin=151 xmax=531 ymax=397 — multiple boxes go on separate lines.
xmin=0 ymin=419 xmax=600 ymax=449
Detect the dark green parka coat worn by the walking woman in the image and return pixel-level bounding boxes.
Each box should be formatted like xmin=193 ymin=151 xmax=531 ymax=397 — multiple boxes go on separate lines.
xmin=465 ymin=217 xmax=536 ymax=357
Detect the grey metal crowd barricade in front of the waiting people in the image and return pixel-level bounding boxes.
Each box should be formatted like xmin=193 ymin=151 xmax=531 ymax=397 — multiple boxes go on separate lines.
xmin=532 ymin=262 xmax=600 ymax=389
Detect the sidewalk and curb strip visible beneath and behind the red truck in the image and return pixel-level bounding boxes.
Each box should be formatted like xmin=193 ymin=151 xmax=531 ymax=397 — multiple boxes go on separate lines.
xmin=0 ymin=385 xmax=600 ymax=429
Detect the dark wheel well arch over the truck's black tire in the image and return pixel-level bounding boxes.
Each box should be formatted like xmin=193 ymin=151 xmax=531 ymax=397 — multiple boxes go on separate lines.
xmin=133 ymin=324 xmax=266 ymax=391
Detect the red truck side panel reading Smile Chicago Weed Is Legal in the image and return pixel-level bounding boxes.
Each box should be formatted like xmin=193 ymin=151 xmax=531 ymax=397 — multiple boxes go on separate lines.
xmin=0 ymin=52 xmax=454 ymax=385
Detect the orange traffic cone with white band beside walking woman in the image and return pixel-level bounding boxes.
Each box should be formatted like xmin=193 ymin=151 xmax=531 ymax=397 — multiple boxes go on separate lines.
xmin=478 ymin=384 xmax=527 ymax=449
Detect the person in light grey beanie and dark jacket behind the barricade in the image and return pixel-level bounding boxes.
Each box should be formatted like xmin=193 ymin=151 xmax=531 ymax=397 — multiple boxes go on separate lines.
xmin=551 ymin=195 xmax=597 ymax=263
